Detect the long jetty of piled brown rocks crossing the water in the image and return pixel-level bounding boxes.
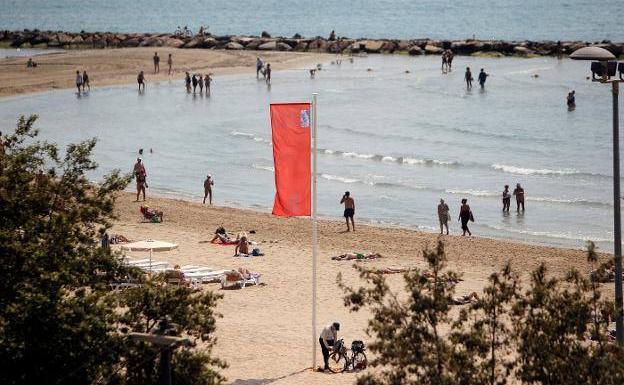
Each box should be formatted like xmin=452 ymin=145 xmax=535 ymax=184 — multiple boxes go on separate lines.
xmin=0 ymin=30 xmax=624 ymax=57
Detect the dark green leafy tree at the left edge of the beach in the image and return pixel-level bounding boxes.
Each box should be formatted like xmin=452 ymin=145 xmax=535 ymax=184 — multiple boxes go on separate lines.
xmin=0 ymin=116 xmax=222 ymax=385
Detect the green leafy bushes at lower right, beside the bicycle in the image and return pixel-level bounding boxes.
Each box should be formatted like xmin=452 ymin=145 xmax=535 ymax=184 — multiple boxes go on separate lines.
xmin=338 ymin=238 xmax=624 ymax=385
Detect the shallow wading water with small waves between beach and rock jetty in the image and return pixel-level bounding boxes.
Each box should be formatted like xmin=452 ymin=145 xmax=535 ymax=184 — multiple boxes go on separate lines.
xmin=0 ymin=55 xmax=613 ymax=250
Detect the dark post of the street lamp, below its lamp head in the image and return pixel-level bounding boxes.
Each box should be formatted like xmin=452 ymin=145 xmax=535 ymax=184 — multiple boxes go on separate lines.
xmin=605 ymin=79 xmax=624 ymax=346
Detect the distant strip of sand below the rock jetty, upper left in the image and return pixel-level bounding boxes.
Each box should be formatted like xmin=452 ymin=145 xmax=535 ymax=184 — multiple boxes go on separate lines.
xmin=0 ymin=47 xmax=329 ymax=97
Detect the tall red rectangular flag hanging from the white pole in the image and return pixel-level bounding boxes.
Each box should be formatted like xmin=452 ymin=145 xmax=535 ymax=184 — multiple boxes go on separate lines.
xmin=271 ymin=103 xmax=311 ymax=217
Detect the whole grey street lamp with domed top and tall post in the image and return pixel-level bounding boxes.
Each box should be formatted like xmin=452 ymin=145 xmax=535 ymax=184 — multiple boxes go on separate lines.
xmin=570 ymin=47 xmax=624 ymax=346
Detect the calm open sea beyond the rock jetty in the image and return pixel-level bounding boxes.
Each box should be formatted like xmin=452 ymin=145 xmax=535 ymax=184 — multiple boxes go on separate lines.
xmin=0 ymin=0 xmax=624 ymax=41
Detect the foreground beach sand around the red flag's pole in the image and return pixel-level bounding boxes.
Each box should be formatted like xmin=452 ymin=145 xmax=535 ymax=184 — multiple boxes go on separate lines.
xmin=111 ymin=194 xmax=606 ymax=385
